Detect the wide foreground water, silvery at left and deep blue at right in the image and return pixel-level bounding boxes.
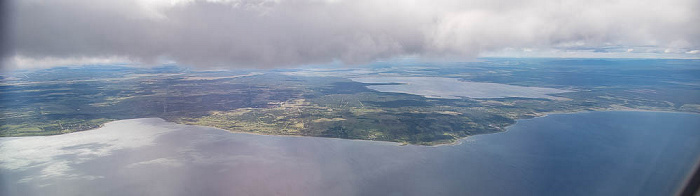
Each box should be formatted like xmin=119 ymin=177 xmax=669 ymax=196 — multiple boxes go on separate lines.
xmin=0 ymin=112 xmax=700 ymax=195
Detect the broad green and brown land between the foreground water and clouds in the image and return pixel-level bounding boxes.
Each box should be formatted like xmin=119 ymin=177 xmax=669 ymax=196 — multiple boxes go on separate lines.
xmin=0 ymin=59 xmax=700 ymax=145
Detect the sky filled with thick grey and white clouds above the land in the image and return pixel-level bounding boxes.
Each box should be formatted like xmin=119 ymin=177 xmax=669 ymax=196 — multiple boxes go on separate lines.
xmin=0 ymin=0 xmax=700 ymax=69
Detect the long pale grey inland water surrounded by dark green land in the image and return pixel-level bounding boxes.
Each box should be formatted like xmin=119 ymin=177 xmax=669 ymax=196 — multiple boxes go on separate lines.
xmin=350 ymin=77 xmax=572 ymax=99
